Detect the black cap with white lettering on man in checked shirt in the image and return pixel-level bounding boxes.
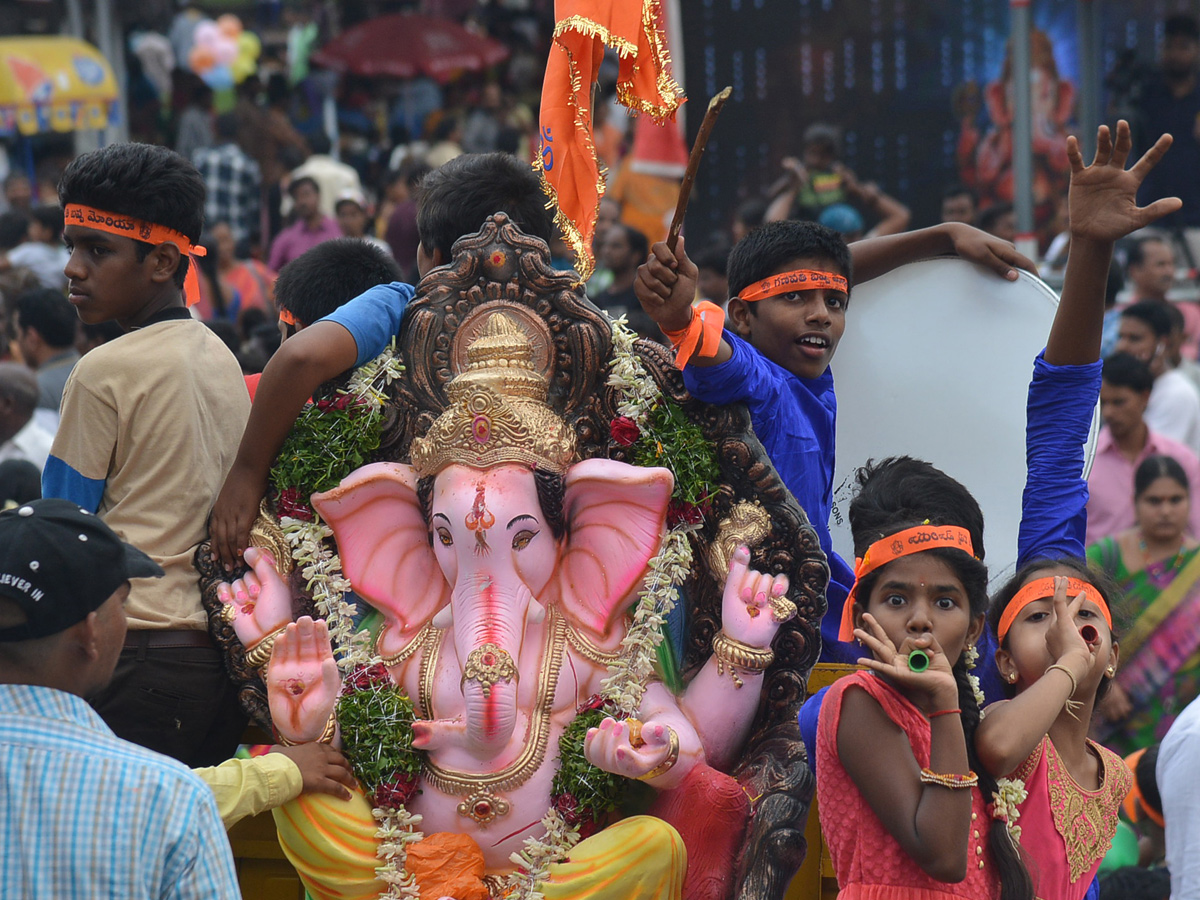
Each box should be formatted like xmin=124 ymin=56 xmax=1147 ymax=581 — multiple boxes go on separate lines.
xmin=0 ymin=499 xmax=163 ymax=642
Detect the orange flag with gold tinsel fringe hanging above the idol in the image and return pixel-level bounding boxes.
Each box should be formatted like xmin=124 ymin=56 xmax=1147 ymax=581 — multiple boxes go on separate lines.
xmin=534 ymin=0 xmax=683 ymax=281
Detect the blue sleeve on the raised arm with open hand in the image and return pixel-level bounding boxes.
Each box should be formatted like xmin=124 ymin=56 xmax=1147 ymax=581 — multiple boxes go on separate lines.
xmin=1016 ymin=350 xmax=1103 ymax=568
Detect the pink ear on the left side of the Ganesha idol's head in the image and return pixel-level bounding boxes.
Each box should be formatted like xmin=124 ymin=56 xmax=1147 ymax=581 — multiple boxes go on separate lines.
xmin=312 ymin=462 xmax=450 ymax=642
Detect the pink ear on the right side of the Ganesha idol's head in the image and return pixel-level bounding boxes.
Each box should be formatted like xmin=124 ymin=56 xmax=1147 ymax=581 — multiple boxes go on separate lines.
xmin=557 ymin=460 xmax=674 ymax=637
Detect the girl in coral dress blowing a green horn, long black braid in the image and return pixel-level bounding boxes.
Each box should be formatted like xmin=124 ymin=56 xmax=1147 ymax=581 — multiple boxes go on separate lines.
xmin=816 ymin=457 xmax=1032 ymax=900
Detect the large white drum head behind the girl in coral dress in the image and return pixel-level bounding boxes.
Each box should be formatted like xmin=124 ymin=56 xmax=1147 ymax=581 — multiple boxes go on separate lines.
xmin=829 ymin=259 xmax=1099 ymax=584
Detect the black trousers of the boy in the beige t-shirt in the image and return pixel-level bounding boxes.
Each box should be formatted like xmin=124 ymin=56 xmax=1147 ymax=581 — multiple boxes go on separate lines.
xmin=89 ymin=632 xmax=247 ymax=768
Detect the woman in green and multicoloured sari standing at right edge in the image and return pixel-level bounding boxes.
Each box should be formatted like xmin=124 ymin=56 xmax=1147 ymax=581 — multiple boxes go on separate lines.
xmin=1087 ymin=456 xmax=1200 ymax=754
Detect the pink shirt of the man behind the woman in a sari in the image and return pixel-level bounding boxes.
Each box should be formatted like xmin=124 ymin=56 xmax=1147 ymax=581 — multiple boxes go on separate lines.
xmin=1086 ymin=425 xmax=1200 ymax=544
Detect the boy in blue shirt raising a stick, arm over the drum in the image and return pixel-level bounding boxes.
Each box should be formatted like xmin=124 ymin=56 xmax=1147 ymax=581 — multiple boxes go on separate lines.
xmin=635 ymin=221 xmax=1033 ymax=662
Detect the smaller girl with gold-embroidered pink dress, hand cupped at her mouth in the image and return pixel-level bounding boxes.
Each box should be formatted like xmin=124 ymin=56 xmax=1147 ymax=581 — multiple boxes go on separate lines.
xmin=976 ymin=559 xmax=1132 ymax=900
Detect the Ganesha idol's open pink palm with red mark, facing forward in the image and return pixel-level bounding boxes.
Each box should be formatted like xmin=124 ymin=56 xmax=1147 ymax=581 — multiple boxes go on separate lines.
xmin=266 ymin=616 xmax=342 ymax=744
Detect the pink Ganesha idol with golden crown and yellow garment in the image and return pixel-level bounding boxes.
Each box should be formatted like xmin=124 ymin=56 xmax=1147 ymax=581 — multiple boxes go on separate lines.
xmin=218 ymin=313 xmax=796 ymax=900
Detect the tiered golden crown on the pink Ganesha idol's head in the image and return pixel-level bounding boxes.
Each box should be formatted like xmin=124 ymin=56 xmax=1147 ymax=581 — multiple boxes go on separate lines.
xmin=412 ymin=313 xmax=575 ymax=478
